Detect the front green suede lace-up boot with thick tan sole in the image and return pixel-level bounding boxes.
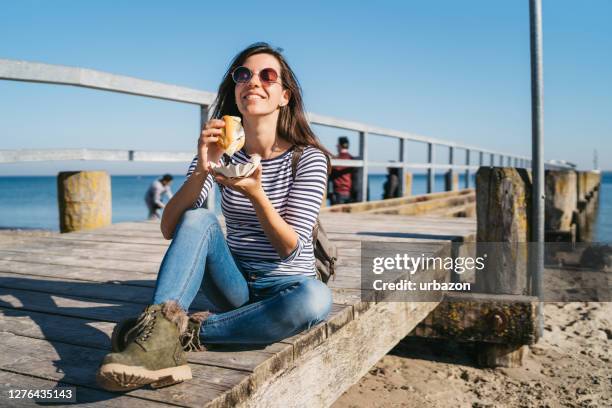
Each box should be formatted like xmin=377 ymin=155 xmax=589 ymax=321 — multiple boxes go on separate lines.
xmin=97 ymin=301 xmax=191 ymax=391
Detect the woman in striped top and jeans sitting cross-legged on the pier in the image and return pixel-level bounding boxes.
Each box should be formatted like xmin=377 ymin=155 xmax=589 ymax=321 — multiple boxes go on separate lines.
xmin=98 ymin=43 xmax=332 ymax=391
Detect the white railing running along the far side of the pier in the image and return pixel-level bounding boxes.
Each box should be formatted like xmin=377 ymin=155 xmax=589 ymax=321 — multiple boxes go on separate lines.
xmin=0 ymin=59 xmax=574 ymax=208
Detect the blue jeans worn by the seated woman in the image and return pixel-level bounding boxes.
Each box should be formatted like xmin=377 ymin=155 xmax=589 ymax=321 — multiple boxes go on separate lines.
xmin=153 ymin=208 xmax=332 ymax=344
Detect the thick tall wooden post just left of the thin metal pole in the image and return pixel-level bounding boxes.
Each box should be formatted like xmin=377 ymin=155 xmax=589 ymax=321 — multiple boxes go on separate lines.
xmin=476 ymin=167 xmax=531 ymax=367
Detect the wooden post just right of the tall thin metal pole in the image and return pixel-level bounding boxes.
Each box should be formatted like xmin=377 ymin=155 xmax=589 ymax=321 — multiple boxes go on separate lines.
xmin=544 ymin=170 xmax=578 ymax=242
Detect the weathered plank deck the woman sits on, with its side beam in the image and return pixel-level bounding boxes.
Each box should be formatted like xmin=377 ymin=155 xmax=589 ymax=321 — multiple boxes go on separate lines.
xmin=0 ymin=213 xmax=476 ymax=407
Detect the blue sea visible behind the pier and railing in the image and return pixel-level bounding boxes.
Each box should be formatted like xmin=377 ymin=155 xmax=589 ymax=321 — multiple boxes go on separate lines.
xmin=0 ymin=172 xmax=612 ymax=243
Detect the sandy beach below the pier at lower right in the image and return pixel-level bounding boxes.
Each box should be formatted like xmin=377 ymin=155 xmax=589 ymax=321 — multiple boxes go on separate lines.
xmin=332 ymin=302 xmax=612 ymax=408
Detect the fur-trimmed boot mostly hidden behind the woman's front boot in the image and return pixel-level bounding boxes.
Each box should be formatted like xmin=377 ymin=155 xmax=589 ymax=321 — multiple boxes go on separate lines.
xmin=111 ymin=311 xmax=213 ymax=353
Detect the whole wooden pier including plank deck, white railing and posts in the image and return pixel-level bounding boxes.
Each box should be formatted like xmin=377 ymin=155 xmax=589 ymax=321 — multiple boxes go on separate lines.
xmin=0 ymin=59 xmax=599 ymax=407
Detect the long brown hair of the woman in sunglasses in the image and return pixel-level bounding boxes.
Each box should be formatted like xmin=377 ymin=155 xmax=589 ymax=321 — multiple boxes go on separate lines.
xmin=212 ymin=42 xmax=331 ymax=173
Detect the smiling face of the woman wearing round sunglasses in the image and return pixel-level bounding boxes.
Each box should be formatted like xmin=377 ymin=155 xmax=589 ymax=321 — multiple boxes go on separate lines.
xmin=234 ymin=54 xmax=290 ymax=117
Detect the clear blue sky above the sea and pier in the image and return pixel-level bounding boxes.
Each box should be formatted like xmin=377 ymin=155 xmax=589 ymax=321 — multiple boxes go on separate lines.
xmin=0 ymin=0 xmax=612 ymax=175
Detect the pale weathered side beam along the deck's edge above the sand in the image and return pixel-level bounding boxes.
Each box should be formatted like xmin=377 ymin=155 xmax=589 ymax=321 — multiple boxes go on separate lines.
xmin=240 ymin=302 xmax=437 ymax=408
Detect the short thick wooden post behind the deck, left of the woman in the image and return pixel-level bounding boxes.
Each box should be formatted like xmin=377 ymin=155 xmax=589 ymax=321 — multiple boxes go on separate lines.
xmin=57 ymin=171 xmax=112 ymax=232
